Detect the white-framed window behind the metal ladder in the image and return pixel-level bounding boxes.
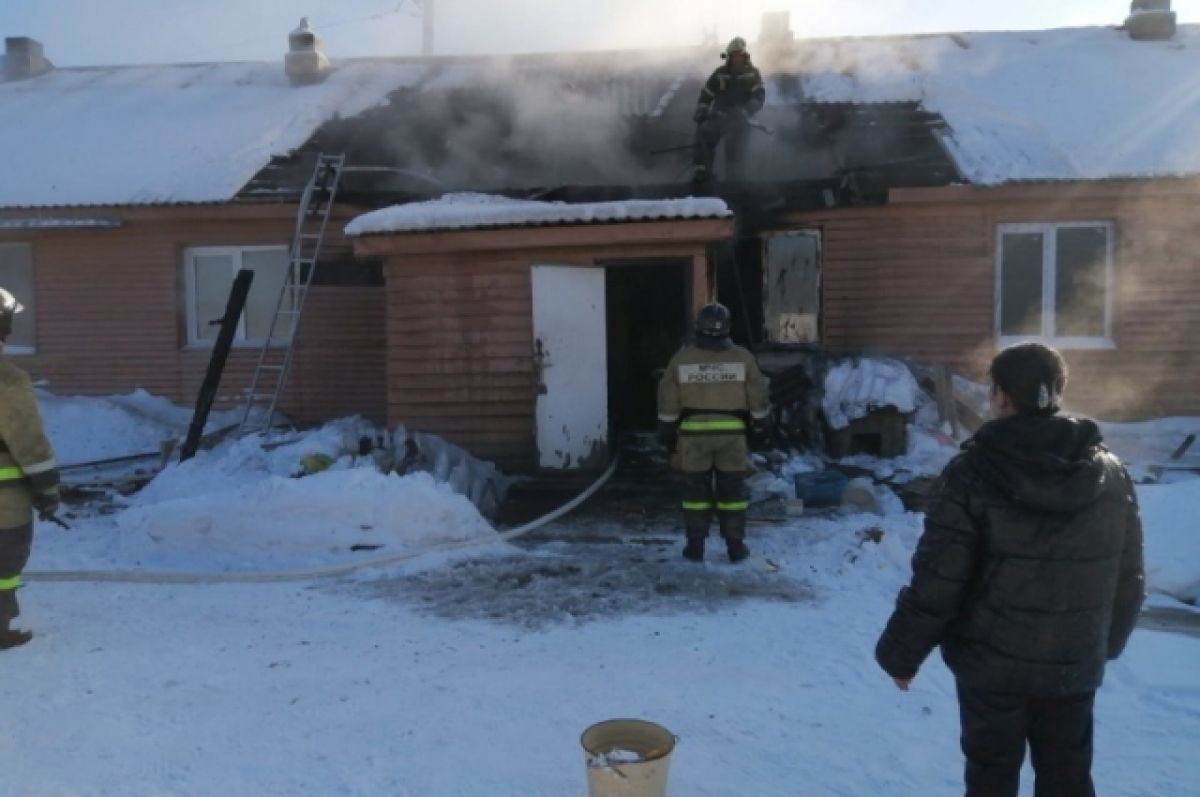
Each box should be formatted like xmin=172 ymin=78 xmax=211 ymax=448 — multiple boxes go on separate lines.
xmin=184 ymin=246 xmax=292 ymax=346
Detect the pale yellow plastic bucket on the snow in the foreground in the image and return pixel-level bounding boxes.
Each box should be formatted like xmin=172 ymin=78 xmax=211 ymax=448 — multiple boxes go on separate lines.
xmin=580 ymin=719 xmax=676 ymax=797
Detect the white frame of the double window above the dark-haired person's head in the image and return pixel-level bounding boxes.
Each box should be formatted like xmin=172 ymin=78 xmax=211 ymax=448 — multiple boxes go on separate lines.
xmin=992 ymin=221 xmax=1117 ymax=349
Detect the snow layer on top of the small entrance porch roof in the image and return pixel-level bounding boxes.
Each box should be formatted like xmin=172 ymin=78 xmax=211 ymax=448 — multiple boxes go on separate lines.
xmin=346 ymin=193 xmax=731 ymax=235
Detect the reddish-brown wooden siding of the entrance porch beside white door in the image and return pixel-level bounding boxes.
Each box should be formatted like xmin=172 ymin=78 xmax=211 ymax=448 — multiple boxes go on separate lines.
xmin=376 ymin=236 xmax=706 ymax=473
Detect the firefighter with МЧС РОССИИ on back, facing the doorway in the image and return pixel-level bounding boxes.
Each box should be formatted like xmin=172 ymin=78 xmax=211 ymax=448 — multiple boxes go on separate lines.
xmin=659 ymin=304 xmax=770 ymax=562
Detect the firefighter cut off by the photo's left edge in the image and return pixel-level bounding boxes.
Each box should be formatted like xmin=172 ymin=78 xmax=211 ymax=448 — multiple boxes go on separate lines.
xmin=0 ymin=288 xmax=59 ymax=649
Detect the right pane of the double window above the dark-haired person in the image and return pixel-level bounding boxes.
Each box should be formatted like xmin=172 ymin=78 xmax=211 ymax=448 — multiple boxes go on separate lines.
xmin=1055 ymin=227 xmax=1109 ymax=337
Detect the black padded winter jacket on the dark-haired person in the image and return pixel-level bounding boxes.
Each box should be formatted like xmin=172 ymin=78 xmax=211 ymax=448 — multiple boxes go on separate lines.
xmin=875 ymin=415 xmax=1144 ymax=696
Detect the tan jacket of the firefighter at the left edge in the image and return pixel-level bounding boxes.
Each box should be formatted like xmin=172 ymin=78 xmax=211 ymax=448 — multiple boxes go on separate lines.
xmin=0 ymin=358 xmax=59 ymax=529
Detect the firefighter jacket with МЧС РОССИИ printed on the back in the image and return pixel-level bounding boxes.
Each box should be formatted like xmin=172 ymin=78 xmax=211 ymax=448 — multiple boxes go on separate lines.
xmin=659 ymin=343 xmax=770 ymax=435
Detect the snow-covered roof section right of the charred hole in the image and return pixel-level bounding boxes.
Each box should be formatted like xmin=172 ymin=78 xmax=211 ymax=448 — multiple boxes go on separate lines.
xmin=792 ymin=25 xmax=1200 ymax=185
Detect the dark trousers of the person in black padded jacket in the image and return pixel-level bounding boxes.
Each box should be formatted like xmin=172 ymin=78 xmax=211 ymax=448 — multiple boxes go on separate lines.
xmin=958 ymin=682 xmax=1096 ymax=797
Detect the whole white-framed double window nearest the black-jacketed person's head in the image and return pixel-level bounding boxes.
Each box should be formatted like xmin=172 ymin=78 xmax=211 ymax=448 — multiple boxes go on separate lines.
xmin=996 ymin=222 xmax=1114 ymax=348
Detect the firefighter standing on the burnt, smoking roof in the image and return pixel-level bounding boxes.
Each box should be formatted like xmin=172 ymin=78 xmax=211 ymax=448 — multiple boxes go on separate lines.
xmin=691 ymin=36 xmax=767 ymax=185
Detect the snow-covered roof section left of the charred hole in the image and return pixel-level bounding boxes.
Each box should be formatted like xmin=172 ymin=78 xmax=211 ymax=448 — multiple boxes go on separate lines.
xmin=0 ymin=62 xmax=425 ymax=208
